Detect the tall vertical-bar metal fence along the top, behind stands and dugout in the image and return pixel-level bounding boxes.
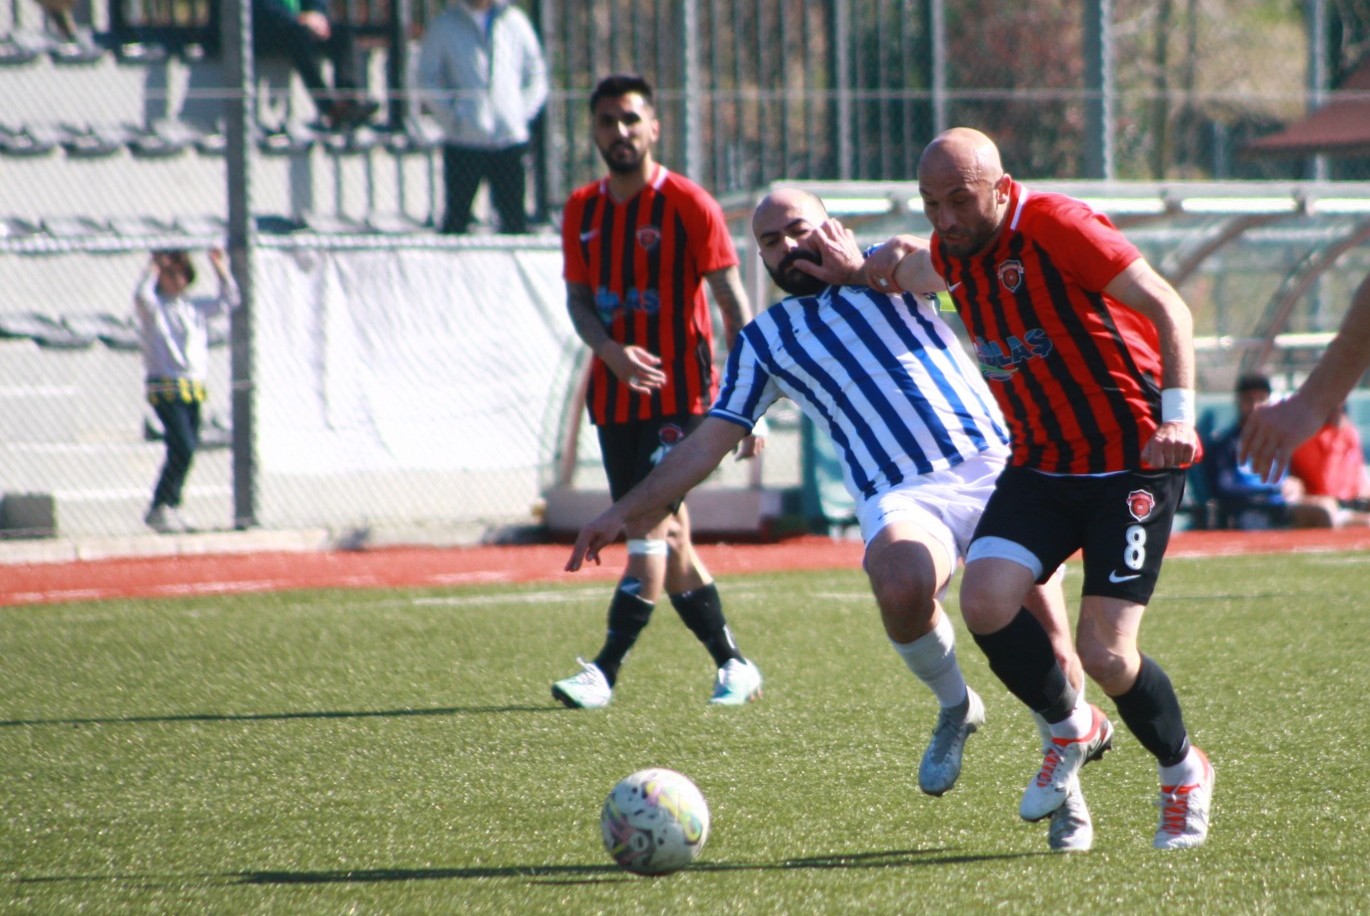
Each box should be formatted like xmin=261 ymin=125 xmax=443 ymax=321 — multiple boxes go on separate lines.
xmin=34 ymin=0 xmax=1370 ymax=198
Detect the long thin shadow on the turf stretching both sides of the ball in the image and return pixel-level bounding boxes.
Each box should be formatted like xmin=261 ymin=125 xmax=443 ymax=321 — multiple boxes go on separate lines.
xmin=238 ymin=849 xmax=1035 ymax=885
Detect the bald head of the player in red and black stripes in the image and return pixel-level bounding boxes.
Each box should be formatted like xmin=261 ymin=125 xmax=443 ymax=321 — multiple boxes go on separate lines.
xmin=918 ymin=127 xmax=1012 ymax=257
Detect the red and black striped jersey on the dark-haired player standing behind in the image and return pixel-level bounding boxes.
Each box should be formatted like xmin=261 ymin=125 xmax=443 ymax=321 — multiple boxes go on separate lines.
xmin=562 ymin=166 xmax=737 ymax=426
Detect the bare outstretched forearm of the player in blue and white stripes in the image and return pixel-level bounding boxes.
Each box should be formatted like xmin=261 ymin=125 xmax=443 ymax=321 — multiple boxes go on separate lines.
xmin=566 ymin=416 xmax=747 ymax=572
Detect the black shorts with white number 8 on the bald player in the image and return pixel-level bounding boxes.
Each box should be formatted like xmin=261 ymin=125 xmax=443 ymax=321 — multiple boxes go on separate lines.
xmin=971 ymin=467 xmax=1185 ymax=604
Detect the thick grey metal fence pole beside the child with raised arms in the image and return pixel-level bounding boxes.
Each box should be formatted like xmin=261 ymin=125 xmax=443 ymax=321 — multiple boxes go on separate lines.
xmin=219 ymin=0 xmax=258 ymax=529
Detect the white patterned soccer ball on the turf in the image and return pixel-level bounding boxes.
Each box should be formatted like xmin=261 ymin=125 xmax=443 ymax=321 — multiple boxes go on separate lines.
xmin=600 ymin=768 xmax=708 ymax=875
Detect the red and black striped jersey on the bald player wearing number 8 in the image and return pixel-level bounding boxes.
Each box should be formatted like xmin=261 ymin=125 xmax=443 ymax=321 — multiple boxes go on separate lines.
xmin=932 ymin=182 xmax=1162 ymax=474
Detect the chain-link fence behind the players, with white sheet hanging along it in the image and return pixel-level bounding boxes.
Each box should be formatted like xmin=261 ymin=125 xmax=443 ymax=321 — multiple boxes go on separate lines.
xmin=0 ymin=0 xmax=1370 ymax=542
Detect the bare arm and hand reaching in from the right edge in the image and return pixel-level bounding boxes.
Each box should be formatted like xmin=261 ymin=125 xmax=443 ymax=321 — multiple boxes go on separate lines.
xmin=1237 ymin=275 xmax=1370 ymax=483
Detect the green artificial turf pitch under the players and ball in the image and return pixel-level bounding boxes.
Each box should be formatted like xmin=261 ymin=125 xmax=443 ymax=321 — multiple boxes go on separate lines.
xmin=0 ymin=553 xmax=1370 ymax=913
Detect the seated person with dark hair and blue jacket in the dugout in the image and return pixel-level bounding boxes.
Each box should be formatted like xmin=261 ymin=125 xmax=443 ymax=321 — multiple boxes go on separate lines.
xmin=1204 ymin=374 xmax=1291 ymax=531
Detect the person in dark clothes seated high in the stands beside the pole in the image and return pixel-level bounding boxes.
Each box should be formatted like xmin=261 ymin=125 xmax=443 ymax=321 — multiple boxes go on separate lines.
xmin=252 ymin=0 xmax=379 ymax=130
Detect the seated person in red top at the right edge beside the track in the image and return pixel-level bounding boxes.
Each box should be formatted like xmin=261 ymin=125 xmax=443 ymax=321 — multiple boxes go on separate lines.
xmin=1289 ymin=403 xmax=1370 ymax=529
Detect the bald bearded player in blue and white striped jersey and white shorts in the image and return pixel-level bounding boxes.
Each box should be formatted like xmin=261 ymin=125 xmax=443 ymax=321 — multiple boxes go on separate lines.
xmin=566 ymin=189 xmax=1092 ymax=849
